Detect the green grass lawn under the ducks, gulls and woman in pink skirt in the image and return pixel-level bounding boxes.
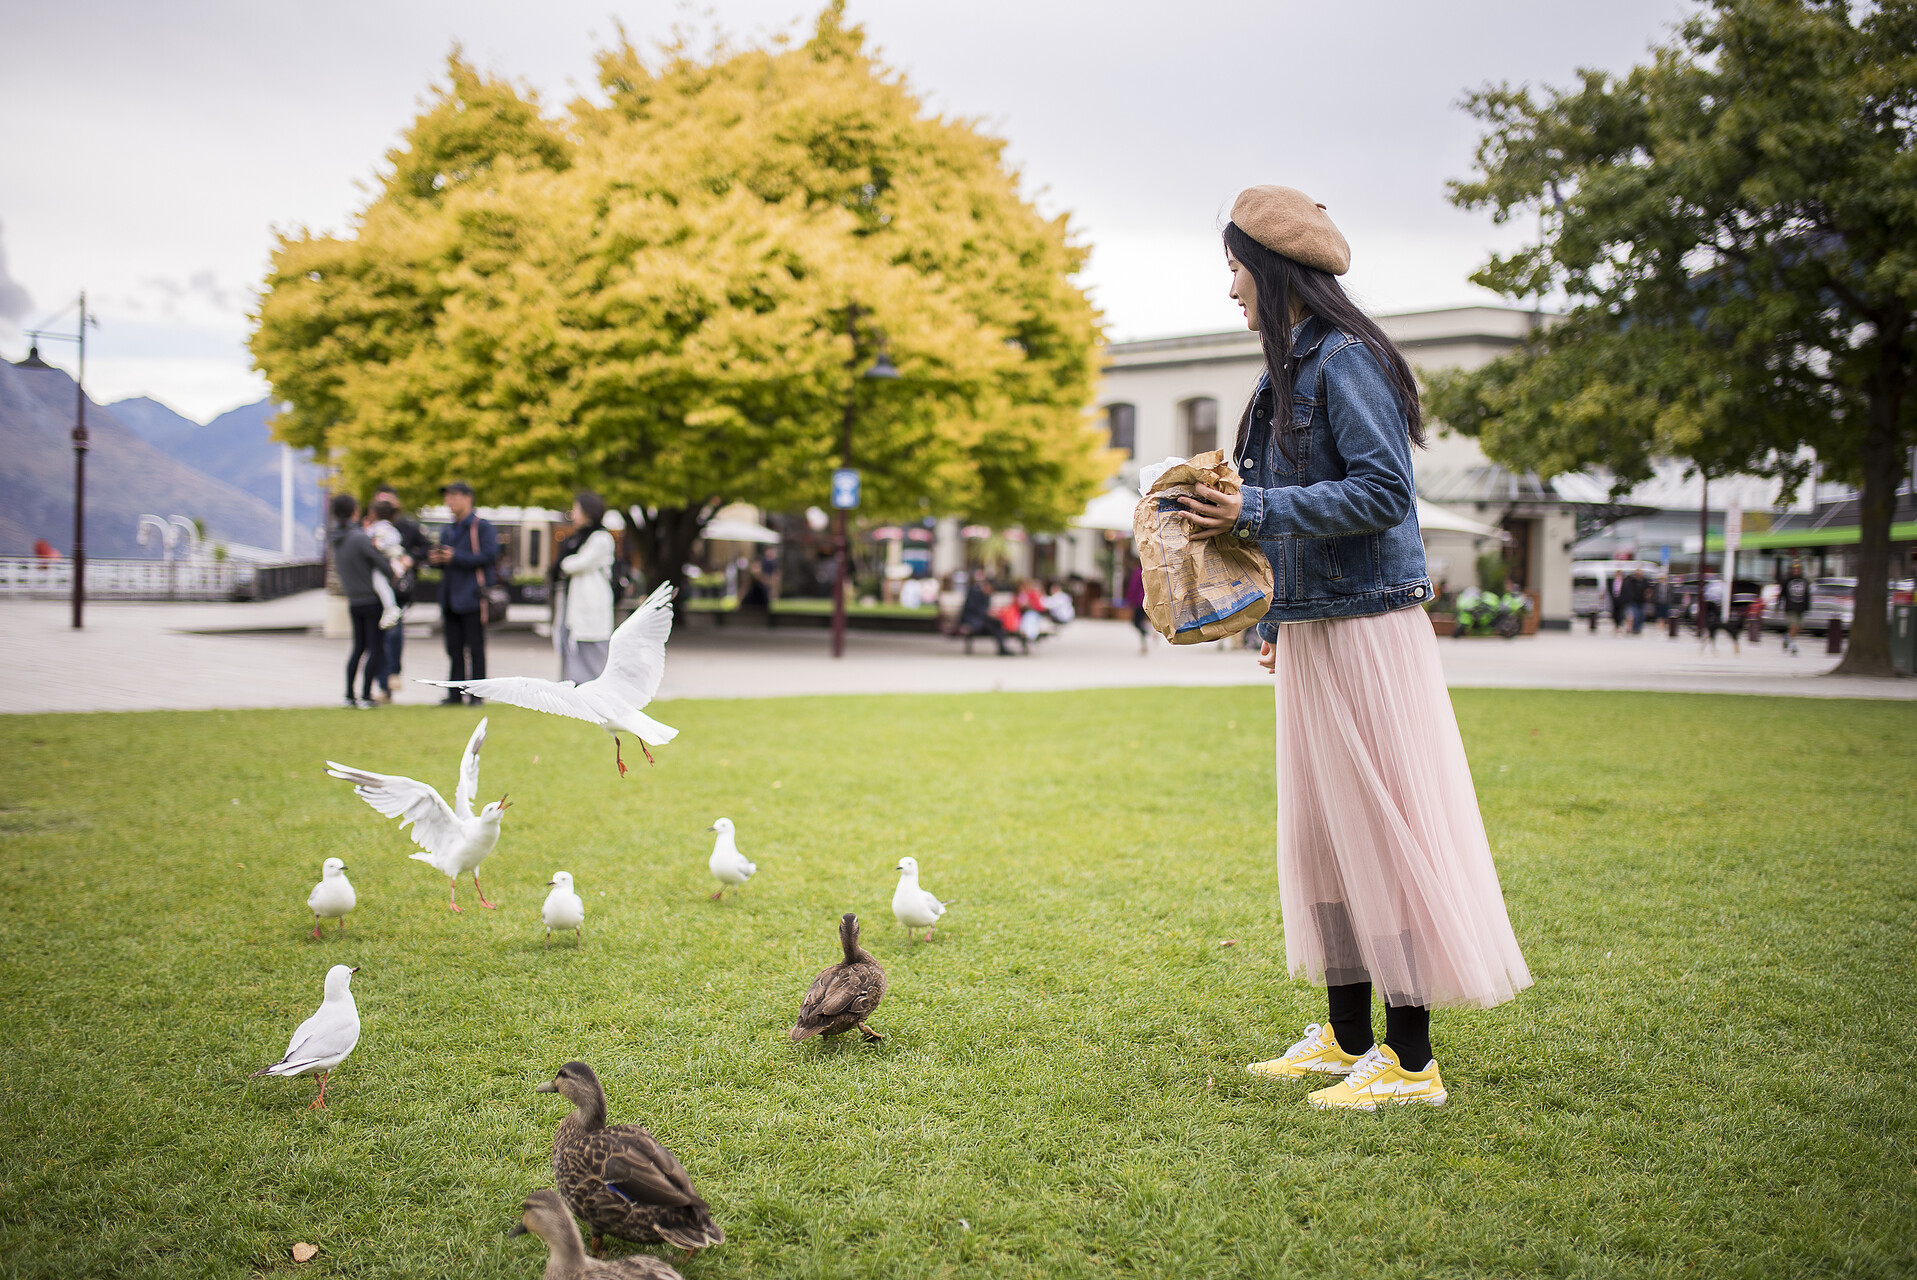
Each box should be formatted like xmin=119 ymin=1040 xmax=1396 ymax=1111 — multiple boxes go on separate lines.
xmin=0 ymin=688 xmax=1917 ymax=1280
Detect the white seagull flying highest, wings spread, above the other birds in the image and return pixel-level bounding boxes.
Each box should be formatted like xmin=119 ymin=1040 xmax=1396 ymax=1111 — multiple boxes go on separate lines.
xmin=422 ymin=583 xmax=679 ymax=778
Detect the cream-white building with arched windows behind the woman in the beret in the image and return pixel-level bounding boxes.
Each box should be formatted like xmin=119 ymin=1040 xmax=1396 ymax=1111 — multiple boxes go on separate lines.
xmin=1056 ymin=307 xmax=1579 ymax=627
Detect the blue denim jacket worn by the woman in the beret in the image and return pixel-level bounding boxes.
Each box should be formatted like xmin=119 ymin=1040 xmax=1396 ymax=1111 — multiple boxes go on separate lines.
xmin=1233 ymin=316 xmax=1432 ymax=640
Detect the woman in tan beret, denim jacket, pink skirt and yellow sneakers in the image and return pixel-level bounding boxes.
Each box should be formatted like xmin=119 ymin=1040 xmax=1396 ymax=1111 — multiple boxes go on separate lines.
xmin=1183 ymin=186 xmax=1532 ymax=1111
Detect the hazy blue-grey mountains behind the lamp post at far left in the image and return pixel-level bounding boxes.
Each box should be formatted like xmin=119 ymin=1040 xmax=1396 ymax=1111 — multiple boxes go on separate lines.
xmin=0 ymin=360 xmax=291 ymax=558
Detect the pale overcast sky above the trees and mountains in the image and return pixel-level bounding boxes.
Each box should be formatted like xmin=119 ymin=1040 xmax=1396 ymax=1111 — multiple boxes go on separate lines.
xmin=0 ymin=0 xmax=1695 ymax=420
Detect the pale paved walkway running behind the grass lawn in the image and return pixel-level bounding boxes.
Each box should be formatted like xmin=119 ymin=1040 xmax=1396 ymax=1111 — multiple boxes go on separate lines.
xmin=0 ymin=592 xmax=1917 ymax=713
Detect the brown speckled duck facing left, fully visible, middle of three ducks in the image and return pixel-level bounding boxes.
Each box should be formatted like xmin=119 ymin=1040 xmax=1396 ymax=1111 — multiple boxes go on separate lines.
xmin=539 ymin=1062 xmax=725 ymax=1257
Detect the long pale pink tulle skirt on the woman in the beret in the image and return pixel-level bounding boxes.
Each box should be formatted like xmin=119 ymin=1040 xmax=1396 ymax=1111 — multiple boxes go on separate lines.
xmin=1275 ymin=607 xmax=1532 ymax=1008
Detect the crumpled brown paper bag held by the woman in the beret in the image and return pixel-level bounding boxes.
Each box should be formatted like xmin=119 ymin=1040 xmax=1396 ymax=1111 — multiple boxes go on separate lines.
xmin=1131 ymin=448 xmax=1271 ymax=644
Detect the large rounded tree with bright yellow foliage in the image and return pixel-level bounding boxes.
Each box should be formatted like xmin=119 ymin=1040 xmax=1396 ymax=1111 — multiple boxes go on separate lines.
xmin=253 ymin=2 xmax=1112 ymax=594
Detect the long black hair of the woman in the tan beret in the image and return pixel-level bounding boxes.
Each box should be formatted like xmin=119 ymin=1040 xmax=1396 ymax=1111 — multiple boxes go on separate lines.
xmin=1225 ymin=222 xmax=1424 ymax=460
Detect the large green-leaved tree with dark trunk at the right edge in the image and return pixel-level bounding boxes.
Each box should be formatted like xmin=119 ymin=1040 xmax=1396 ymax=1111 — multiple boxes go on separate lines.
xmin=1430 ymin=0 xmax=1917 ymax=674
